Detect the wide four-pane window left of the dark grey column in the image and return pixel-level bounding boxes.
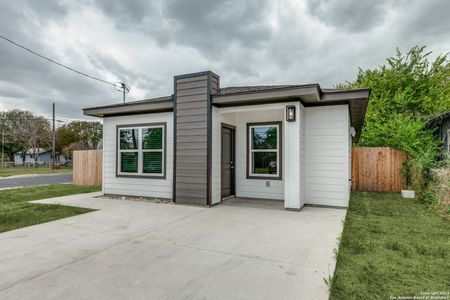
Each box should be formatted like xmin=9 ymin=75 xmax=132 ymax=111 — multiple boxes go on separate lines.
xmin=117 ymin=123 xmax=166 ymax=178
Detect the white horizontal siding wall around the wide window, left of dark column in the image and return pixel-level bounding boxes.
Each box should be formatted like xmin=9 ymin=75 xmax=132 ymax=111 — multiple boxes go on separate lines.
xmin=103 ymin=112 xmax=173 ymax=199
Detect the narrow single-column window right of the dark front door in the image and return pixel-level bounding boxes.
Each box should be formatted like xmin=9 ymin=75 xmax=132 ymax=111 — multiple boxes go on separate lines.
xmin=247 ymin=122 xmax=281 ymax=179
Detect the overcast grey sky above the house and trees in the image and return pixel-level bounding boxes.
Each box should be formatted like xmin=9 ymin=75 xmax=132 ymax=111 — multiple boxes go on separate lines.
xmin=0 ymin=0 xmax=450 ymax=119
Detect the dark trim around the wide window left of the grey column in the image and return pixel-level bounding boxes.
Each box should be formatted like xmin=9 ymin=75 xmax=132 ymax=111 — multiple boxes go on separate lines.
xmin=116 ymin=122 xmax=167 ymax=179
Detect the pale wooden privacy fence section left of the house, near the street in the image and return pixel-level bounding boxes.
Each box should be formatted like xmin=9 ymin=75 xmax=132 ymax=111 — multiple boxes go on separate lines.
xmin=73 ymin=150 xmax=103 ymax=185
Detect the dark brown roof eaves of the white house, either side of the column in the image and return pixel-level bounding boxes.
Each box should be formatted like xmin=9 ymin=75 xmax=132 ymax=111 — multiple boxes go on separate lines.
xmin=83 ymin=84 xmax=370 ymax=136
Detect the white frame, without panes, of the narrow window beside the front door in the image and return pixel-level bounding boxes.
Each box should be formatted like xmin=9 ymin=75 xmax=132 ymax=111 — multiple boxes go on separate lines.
xmin=247 ymin=122 xmax=282 ymax=180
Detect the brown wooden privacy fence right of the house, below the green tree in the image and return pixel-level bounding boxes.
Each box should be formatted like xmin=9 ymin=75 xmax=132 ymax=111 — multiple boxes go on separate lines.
xmin=352 ymin=147 xmax=406 ymax=192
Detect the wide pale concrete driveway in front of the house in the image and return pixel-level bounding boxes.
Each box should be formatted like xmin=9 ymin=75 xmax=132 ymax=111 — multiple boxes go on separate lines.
xmin=0 ymin=194 xmax=346 ymax=300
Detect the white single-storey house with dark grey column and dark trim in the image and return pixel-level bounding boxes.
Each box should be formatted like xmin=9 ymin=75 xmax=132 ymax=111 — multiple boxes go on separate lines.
xmin=84 ymin=71 xmax=370 ymax=210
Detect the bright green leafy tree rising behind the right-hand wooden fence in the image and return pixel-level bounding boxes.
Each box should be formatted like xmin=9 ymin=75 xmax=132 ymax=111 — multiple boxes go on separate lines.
xmin=346 ymin=46 xmax=450 ymax=155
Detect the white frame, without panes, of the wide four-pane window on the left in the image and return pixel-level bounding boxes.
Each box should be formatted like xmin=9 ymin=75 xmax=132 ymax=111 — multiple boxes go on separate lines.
xmin=116 ymin=123 xmax=166 ymax=179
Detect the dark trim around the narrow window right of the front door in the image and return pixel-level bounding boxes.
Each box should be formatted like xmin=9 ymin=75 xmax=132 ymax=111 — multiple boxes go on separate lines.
xmin=246 ymin=121 xmax=283 ymax=180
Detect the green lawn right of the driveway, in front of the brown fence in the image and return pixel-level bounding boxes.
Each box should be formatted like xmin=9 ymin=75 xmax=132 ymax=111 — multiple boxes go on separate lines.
xmin=330 ymin=192 xmax=450 ymax=300
